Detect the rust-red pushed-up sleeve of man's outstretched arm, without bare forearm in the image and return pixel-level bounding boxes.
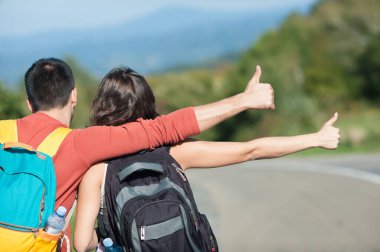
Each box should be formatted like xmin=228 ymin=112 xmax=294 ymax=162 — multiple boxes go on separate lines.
xmin=72 ymin=108 xmax=200 ymax=167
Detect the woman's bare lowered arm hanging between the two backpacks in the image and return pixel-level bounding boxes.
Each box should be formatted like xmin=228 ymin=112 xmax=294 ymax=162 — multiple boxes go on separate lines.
xmin=74 ymin=163 xmax=105 ymax=252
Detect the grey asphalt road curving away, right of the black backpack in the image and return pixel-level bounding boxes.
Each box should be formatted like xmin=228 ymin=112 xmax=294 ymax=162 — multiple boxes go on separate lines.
xmin=187 ymin=153 xmax=380 ymax=252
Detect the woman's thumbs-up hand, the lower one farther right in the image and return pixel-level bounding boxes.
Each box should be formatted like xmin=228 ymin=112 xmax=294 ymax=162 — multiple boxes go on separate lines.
xmin=317 ymin=112 xmax=340 ymax=150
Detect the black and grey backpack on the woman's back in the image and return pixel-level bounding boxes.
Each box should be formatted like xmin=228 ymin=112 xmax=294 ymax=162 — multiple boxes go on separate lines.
xmin=98 ymin=147 xmax=218 ymax=252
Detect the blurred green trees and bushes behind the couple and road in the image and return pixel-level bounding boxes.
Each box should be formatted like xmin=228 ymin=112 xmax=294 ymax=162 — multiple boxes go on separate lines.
xmin=0 ymin=0 xmax=380 ymax=153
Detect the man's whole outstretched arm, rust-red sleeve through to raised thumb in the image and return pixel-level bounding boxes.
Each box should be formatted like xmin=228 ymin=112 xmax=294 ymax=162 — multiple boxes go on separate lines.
xmin=74 ymin=67 xmax=274 ymax=166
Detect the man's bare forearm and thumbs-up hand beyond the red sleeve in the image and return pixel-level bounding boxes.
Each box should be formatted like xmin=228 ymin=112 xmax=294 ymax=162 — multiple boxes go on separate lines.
xmin=194 ymin=66 xmax=275 ymax=131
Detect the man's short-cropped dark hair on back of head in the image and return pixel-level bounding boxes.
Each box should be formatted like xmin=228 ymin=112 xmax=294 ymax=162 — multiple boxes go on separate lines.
xmin=25 ymin=58 xmax=74 ymax=112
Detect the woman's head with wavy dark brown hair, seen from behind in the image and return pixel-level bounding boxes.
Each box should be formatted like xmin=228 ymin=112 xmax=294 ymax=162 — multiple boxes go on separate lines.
xmin=90 ymin=67 xmax=159 ymax=126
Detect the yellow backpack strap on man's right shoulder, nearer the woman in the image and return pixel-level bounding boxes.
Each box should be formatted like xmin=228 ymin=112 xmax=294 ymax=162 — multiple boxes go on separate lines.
xmin=37 ymin=127 xmax=71 ymax=157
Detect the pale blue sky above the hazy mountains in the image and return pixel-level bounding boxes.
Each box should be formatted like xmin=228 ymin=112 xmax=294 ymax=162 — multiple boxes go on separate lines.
xmin=0 ymin=0 xmax=315 ymax=37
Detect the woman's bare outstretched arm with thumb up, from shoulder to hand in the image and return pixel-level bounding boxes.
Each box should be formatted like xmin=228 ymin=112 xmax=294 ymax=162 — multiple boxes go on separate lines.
xmin=170 ymin=113 xmax=340 ymax=169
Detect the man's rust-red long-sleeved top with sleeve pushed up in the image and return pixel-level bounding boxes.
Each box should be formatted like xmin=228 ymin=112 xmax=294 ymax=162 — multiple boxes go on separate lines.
xmin=17 ymin=108 xmax=200 ymax=213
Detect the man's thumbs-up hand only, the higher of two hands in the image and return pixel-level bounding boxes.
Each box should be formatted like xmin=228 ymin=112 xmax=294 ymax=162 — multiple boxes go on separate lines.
xmin=243 ymin=66 xmax=275 ymax=110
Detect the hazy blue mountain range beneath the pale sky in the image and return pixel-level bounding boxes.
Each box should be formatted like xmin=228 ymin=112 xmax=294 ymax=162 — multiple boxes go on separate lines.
xmin=0 ymin=6 xmax=308 ymax=86
